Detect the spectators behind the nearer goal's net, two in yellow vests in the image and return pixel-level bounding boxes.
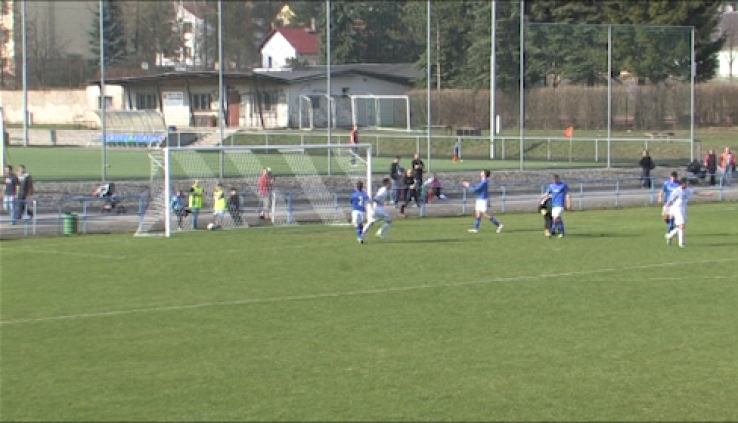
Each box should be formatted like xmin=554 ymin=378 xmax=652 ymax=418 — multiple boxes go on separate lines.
xmin=170 ymin=167 xmax=274 ymax=230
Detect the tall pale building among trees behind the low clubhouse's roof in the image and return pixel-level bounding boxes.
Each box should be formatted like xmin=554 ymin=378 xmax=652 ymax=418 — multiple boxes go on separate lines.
xmin=157 ymin=1 xmax=217 ymax=70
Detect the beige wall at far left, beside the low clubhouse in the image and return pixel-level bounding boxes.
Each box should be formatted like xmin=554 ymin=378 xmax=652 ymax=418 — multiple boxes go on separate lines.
xmin=0 ymin=85 xmax=123 ymax=125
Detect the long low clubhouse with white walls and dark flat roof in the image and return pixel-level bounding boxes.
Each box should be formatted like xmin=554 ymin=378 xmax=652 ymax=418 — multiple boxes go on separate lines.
xmin=88 ymin=63 xmax=420 ymax=129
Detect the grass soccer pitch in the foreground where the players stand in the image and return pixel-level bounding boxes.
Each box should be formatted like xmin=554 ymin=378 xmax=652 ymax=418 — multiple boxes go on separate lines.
xmin=0 ymin=203 xmax=738 ymax=421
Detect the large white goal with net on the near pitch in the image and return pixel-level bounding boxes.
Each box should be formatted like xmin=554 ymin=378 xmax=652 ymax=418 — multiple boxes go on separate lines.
xmin=136 ymin=144 xmax=372 ymax=236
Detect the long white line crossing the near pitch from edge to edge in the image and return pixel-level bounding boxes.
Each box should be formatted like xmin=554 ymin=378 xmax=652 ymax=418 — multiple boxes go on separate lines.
xmin=0 ymin=258 xmax=738 ymax=325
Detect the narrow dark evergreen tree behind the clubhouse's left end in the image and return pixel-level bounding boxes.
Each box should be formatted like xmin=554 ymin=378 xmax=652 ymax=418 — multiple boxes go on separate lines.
xmin=88 ymin=0 xmax=127 ymax=67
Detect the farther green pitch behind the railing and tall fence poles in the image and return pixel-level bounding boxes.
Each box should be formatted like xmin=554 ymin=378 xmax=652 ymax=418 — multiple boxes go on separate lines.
xmin=2 ymin=131 xmax=738 ymax=181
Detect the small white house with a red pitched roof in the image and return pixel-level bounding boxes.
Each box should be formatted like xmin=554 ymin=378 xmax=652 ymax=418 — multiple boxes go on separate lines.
xmin=259 ymin=28 xmax=320 ymax=69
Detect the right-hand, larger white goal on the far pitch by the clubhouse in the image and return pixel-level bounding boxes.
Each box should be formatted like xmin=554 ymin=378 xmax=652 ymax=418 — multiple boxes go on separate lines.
xmin=349 ymin=95 xmax=410 ymax=131
